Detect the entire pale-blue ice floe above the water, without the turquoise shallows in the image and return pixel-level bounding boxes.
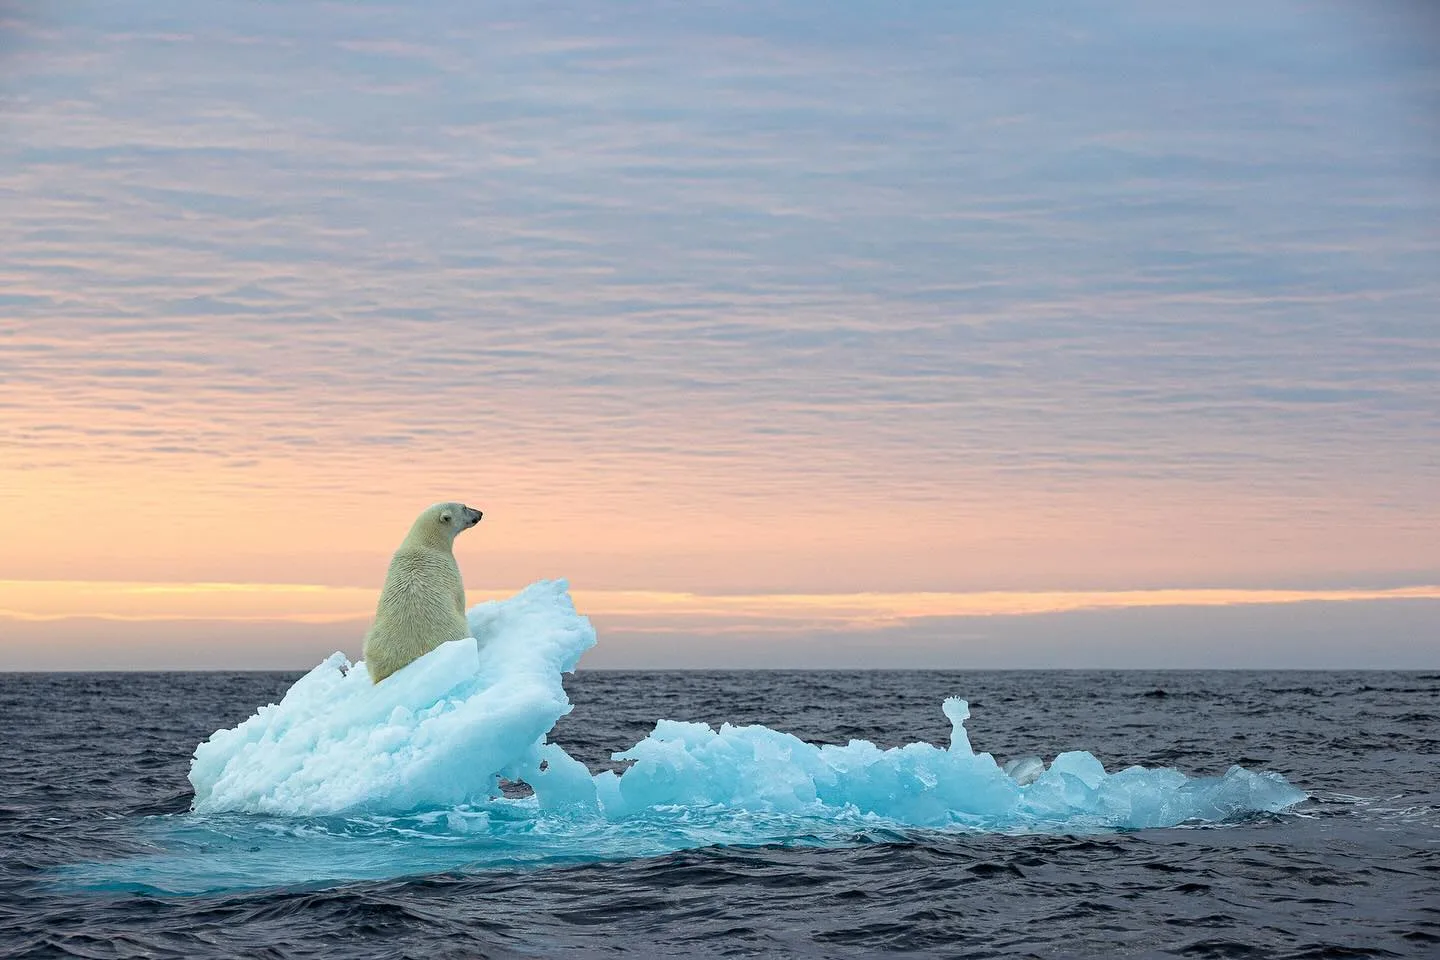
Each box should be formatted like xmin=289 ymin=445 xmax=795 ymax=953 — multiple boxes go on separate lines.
xmin=190 ymin=581 xmax=1305 ymax=839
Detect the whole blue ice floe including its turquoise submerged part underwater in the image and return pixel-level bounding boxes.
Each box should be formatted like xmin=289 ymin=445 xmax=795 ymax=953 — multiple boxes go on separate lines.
xmin=61 ymin=580 xmax=1306 ymax=894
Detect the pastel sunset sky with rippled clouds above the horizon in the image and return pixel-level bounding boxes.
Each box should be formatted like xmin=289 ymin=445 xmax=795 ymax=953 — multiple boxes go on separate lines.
xmin=0 ymin=0 xmax=1440 ymax=669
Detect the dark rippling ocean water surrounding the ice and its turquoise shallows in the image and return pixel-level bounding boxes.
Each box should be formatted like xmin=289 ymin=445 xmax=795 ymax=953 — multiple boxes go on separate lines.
xmin=0 ymin=672 xmax=1440 ymax=960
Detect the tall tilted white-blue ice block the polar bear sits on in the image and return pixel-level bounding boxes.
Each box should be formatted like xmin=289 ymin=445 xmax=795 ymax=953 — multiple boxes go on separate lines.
xmin=190 ymin=580 xmax=595 ymax=816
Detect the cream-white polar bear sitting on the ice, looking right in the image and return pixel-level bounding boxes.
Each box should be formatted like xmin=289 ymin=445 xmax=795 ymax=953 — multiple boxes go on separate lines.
xmin=364 ymin=504 xmax=481 ymax=684
